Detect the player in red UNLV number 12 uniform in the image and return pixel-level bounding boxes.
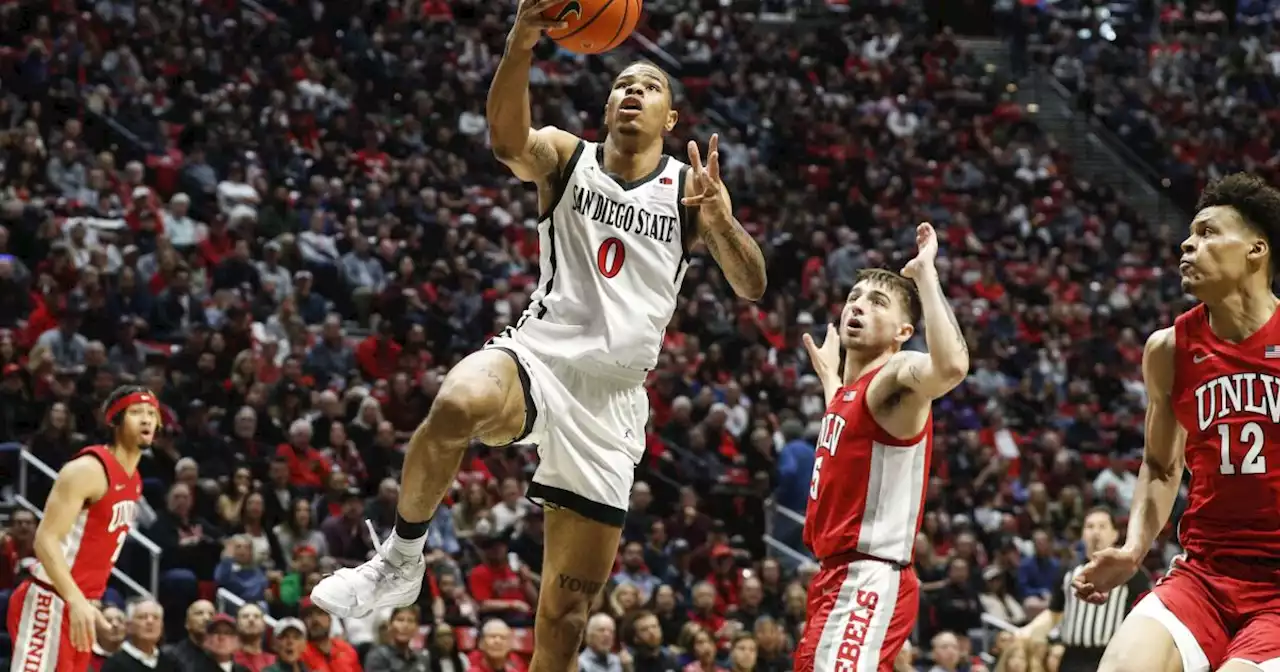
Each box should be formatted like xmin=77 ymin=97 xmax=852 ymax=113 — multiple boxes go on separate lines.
xmin=1075 ymin=173 xmax=1280 ymax=672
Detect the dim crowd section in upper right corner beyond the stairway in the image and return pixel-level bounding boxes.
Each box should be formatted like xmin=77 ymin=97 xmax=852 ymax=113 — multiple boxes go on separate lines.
xmin=1029 ymin=0 xmax=1280 ymax=209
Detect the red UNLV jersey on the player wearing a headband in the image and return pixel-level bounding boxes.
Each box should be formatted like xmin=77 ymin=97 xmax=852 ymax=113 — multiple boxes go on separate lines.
xmin=31 ymin=445 xmax=142 ymax=599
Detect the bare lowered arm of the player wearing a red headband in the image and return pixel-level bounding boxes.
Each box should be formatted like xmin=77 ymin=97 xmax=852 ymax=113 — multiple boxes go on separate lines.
xmin=35 ymin=456 xmax=111 ymax=650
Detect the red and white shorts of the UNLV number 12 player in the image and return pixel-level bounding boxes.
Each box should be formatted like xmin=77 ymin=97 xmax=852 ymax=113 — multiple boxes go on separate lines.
xmin=1132 ymin=557 xmax=1280 ymax=672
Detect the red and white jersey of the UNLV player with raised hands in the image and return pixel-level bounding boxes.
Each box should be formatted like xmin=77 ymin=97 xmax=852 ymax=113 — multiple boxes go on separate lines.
xmin=804 ymin=369 xmax=933 ymax=564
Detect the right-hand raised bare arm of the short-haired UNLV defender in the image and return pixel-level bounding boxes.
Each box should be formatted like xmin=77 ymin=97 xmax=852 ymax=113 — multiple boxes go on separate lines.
xmin=895 ymin=223 xmax=969 ymax=399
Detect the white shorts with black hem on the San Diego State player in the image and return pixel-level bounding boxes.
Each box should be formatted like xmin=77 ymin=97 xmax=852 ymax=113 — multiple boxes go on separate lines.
xmin=485 ymin=335 xmax=649 ymax=527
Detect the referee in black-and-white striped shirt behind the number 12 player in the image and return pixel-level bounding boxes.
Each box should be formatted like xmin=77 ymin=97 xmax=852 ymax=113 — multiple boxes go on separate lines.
xmin=1019 ymin=508 xmax=1151 ymax=672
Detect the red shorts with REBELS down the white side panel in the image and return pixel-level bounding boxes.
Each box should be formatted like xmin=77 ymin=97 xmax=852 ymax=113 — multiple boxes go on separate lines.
xmin=795 ymin=559 xmax=920 ymax=672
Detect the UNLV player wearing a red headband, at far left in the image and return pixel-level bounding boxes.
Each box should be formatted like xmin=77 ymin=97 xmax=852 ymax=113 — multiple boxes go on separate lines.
xmin=9 ymin=385 xmax=160 ymax=672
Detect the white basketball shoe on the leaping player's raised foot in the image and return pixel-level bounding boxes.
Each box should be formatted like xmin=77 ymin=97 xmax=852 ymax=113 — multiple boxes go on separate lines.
xmin=311 ymin=521 xmax=426 ymax=618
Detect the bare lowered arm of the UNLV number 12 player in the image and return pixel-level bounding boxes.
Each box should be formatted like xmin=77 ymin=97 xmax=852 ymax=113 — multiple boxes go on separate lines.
xmin=1074 ymin=328 xmax=1187 ymax=603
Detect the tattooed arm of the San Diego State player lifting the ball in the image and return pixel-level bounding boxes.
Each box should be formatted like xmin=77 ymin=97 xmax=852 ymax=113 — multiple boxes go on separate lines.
xmin=485 ymin=0 xmax=577 ymax=182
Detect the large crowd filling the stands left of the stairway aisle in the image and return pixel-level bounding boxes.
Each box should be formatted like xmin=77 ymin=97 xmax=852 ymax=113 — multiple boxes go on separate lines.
xmin=0 ymin=0 xmax=1184 ymax=672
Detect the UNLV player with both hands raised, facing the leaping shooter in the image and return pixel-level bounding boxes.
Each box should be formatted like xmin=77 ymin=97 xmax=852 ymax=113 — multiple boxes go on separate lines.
xmin=795 ymin=224 xmax=969 ymax=672
